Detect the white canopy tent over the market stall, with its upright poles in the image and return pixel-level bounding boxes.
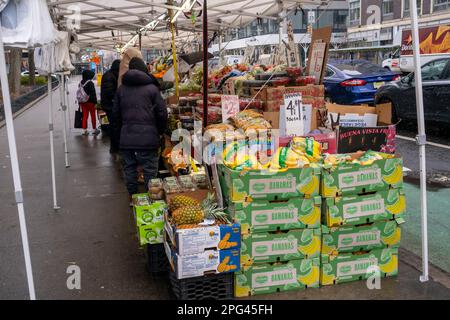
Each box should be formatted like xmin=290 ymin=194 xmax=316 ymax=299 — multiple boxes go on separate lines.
xmin=0 ymin=0 xmax=428 ymax=299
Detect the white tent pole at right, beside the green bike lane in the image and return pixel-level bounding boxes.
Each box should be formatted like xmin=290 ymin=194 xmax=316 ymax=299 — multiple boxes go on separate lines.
xmin=409 ymin=0 xmax=428 ymax=282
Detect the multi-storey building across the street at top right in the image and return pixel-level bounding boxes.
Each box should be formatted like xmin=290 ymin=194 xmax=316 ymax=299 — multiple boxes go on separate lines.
xmin=344 ymin=0 xmax=450 ymax=63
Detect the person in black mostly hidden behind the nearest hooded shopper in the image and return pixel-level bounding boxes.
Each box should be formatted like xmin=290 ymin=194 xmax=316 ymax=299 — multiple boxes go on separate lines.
xmin=100 ymin=59 xmax=120 ymax=153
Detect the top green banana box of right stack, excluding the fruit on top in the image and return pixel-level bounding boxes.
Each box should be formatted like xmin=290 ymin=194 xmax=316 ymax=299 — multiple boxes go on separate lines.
xmin=321 ymin=156 xmax=403 ymax=198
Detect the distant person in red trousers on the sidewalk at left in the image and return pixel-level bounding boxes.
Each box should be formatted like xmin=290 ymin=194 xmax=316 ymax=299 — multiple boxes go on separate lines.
xmin=80 ymin=70 xmax=100 ymax=136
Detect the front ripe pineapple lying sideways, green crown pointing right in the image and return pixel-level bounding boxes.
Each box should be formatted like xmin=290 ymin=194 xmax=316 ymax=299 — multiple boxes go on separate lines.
xmin=171 ymin=193 xmax=230 ymax=225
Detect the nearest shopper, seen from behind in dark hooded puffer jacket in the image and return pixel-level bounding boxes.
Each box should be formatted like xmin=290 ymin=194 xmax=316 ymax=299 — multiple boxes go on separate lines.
xmin=113 ymin=57 xmax=167 ymax=200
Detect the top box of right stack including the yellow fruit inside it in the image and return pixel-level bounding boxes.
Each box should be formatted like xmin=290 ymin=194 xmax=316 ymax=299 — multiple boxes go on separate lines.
xmin=321 ymin=151 xmax=403 ymax=198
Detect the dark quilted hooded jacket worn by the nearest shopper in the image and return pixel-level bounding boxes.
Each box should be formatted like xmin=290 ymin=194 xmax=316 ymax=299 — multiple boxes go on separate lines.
xmin=113 ymin=70 xmax=167 ymax=150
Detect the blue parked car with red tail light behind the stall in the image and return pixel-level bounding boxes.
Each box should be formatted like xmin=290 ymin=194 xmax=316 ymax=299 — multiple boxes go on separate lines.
xmin=324 ymin=60 xmax=400 ymax=104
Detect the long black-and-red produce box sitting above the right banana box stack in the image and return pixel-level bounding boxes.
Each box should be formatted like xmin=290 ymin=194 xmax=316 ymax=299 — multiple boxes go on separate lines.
xmin=337 ymin=125 xmax=396 ymax=153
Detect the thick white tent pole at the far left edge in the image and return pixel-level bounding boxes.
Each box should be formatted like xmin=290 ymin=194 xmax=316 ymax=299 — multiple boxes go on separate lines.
xmin=0 ymin=29 xmax=36 ymax=300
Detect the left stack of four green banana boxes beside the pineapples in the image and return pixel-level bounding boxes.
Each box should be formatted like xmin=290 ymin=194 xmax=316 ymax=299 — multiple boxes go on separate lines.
xmin=218 ymin=165 xmax=322 ymax=297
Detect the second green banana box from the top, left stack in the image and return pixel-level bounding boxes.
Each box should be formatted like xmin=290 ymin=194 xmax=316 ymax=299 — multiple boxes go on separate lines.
xmin=227 ymin=196 xmax=322 ymax=235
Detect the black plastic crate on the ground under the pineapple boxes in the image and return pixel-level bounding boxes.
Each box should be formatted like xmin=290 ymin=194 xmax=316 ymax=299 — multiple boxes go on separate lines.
xmin=169 ymin=271 xmax=234 ymax=300
